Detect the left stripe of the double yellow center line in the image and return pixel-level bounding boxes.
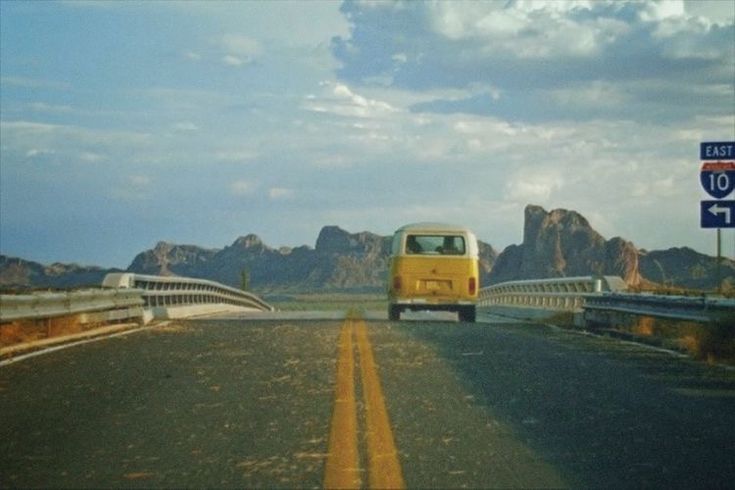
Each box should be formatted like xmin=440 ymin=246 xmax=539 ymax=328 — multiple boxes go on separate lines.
xmin=324 ymin=320 xmax=361 ymax=488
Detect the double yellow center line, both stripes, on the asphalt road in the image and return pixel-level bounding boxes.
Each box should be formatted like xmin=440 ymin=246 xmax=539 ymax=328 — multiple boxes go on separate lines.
xmin=324 ymin=315 xmax=405 ymax=488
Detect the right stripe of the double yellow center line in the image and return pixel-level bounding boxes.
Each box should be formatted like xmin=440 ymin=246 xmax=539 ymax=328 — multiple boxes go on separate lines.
xmin=355 ymin=320 xmax=406 ymax=488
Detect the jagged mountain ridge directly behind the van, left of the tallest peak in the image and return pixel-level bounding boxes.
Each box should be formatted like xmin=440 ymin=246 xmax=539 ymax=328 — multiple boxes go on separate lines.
xmin=128 ymin=226 xmax=497 ymax=291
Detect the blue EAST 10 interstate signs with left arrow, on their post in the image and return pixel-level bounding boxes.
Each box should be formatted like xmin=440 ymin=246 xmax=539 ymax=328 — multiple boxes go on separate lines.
xmin=699 ymin=141 xmax=735 ymax=293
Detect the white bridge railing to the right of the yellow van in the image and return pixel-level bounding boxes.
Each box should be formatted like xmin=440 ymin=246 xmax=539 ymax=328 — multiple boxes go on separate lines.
xmin=478 ymin=276 xmax=626 ymax=311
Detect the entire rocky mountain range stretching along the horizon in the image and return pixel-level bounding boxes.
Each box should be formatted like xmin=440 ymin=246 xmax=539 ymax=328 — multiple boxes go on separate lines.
xmin=0 ymin=209 xmax=735 ymax=292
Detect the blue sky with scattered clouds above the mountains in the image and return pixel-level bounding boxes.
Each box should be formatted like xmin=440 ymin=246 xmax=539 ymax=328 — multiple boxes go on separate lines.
xmin=0 ymin=0 xmax=735 ymax=268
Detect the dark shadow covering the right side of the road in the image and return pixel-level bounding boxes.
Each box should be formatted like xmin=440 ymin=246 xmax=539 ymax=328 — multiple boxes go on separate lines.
xmin=393 ymin=323 xmax=735 ymax=488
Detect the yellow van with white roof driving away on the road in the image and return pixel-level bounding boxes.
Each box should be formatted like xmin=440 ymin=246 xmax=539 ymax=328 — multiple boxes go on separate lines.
xmin=388 ymin=223 xmax=480 ymax=322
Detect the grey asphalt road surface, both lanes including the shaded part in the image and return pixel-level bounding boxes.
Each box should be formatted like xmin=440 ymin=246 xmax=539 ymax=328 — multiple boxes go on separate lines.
xmin=0 ymin=312 xmax=735 ymax=488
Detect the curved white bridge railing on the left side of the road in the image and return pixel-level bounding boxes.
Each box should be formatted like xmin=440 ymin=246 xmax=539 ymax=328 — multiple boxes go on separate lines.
xmin=102 ymin=272 xmax=274 ymax=318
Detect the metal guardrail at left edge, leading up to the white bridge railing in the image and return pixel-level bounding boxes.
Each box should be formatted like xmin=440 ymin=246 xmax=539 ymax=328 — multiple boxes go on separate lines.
xmin=0 ymin=289 xmax=144 ymax=323
